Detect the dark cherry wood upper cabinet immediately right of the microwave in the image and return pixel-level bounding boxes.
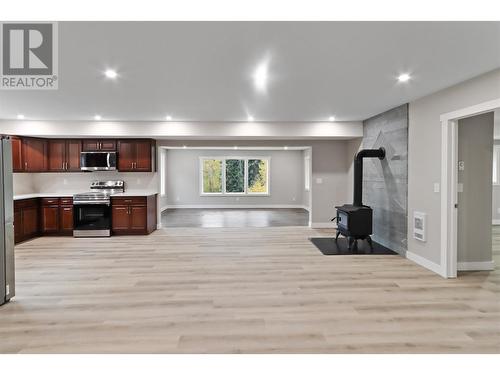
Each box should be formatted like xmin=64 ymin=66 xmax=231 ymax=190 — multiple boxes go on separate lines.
xmin=118 ymin=139 xmax=154 ymax=172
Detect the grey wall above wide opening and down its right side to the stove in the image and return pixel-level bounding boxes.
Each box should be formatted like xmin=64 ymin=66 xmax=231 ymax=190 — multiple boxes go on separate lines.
xmin=159 ymin=140 xmax=352 ymax=226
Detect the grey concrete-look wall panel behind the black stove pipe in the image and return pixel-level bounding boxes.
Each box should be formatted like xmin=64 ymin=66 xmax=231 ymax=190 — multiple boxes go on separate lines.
xmin=363 ymin=104 xmax=408 ymax=253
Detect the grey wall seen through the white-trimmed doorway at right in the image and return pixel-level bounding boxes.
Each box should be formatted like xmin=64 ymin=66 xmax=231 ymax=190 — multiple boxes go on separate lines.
xmin=457 ymin=112 xmax=493 ymax=263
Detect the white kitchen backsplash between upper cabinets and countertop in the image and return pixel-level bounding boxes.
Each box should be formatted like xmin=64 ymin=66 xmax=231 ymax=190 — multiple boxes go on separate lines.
xmin=14 ymin=172 xmax=158 ymax=195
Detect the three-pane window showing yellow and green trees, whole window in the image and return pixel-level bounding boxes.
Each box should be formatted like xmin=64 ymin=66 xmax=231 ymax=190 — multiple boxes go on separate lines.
xmin=200 ymin=157 xmax=270 ymax=195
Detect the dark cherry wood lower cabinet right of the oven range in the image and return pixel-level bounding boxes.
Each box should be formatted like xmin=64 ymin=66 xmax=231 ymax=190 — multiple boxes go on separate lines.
xmin=111 ymin=195 xmax=156 ymax=235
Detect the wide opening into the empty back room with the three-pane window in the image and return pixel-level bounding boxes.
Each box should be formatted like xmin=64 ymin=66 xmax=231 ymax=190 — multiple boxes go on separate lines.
xmin=160 ymin=145 xmax=312 ymax=228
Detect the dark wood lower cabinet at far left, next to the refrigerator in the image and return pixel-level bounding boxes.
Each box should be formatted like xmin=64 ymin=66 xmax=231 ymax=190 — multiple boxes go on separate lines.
xmin=14 ymin=198 xmax=39 ymax=243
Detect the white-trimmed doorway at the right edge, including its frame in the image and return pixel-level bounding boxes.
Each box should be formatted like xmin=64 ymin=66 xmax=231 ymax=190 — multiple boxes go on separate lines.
xmin=440 ymin=99 xmax=500 ymax=277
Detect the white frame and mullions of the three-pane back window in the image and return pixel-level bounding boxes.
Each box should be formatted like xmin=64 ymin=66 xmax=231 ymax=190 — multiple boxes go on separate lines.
xmin=198 ymin=155 xmax=271 ymax=197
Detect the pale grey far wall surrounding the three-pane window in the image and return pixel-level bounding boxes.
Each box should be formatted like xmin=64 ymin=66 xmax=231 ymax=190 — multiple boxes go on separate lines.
xmin=167 ymin=149 xmax=305 ymax=206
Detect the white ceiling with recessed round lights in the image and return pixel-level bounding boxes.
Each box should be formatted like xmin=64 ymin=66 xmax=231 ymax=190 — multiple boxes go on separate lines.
xmin=0 ymin=22 xmax=500 ymax=121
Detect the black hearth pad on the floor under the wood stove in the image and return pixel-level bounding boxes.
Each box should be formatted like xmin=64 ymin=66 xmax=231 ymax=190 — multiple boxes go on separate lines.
xmin=309 ymin=237 xmax=397 ymax=255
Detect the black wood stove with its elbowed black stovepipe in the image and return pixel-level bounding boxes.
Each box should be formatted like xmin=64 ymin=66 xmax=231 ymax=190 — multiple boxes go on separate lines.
xmin=332 ymin=147 xmax=385 ymax=250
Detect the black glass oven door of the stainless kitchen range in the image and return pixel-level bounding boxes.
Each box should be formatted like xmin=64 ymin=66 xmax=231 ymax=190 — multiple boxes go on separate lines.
xmin=73 ymin=203 xmax=111 ymax=237
